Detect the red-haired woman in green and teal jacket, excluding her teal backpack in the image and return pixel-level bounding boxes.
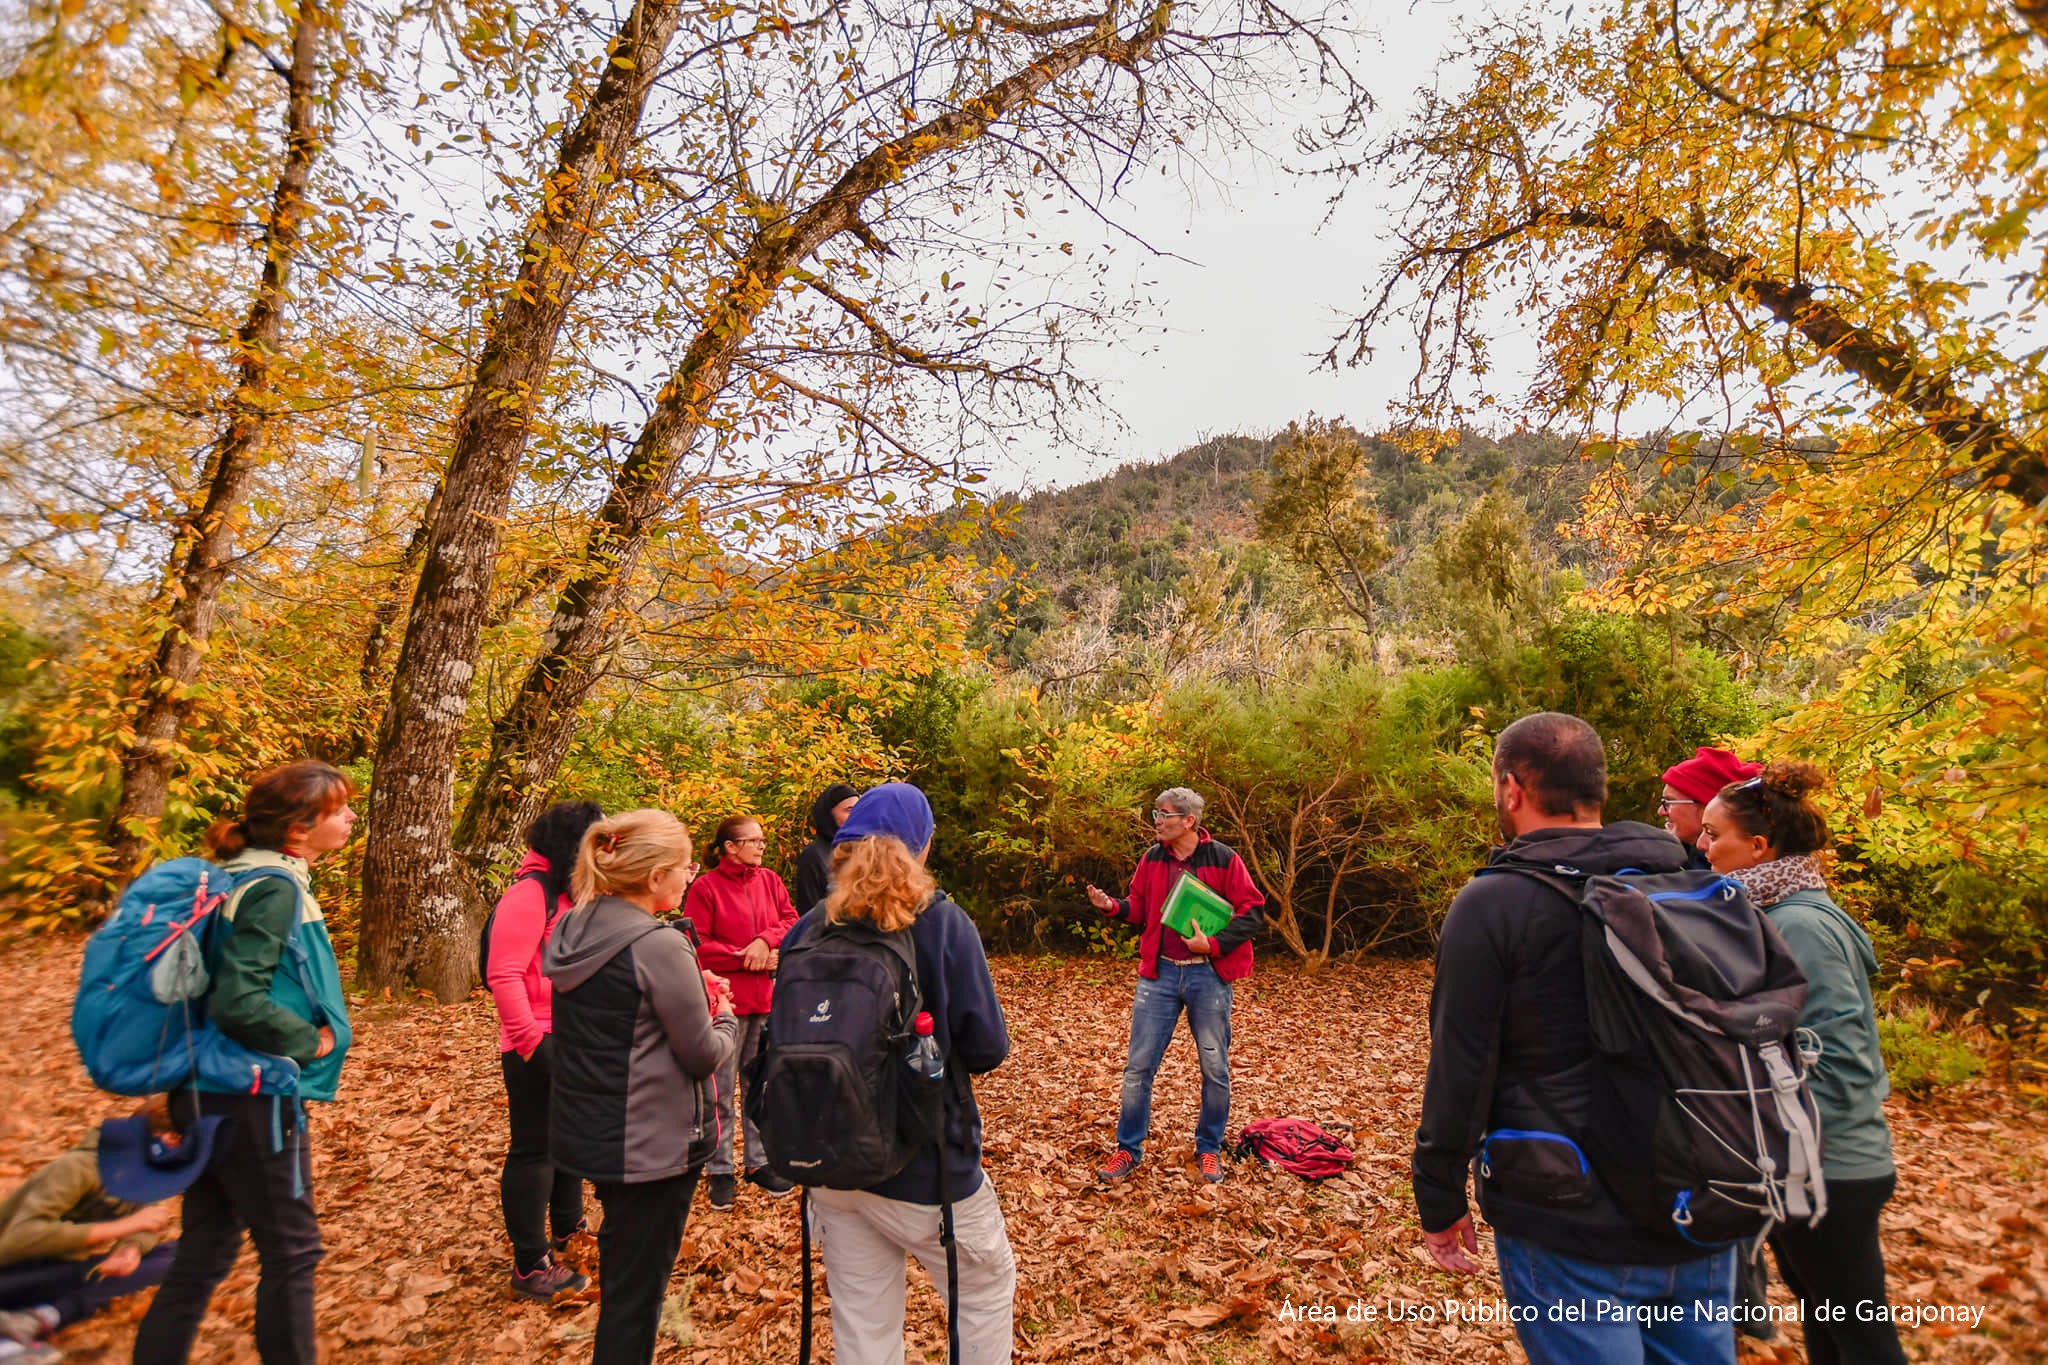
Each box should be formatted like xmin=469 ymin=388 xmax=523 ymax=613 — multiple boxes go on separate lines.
xmin=135 ymin=759 xmax=356 ymax=1365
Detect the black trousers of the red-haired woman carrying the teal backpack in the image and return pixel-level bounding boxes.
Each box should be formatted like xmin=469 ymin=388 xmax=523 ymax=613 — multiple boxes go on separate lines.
xmin=135 ymin=1091 xmax=324 ymax=1365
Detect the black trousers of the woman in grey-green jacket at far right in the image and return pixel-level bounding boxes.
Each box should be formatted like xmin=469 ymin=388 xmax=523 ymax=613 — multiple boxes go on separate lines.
xmin=1772 ymin=1175 xmax=1907 ymax=1365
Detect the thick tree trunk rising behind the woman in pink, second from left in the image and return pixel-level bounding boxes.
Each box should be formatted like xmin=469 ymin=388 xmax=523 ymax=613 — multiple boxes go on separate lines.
xmin=358 ymin=0 xmax=682 ymax=1001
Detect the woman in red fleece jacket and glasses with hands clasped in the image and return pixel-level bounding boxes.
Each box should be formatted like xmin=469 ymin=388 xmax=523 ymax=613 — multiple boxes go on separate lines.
xmin=682 ymin=814 xmax=797 ymax=1209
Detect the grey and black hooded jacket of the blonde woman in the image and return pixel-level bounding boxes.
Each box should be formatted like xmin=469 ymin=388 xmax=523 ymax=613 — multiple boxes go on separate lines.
xmin=543 ymin=896 xmax=739 ymax=1185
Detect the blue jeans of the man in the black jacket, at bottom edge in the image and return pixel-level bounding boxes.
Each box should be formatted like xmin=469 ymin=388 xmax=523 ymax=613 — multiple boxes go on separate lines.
xmin=1493 ymin=1234 xmax=1735 ymax=1365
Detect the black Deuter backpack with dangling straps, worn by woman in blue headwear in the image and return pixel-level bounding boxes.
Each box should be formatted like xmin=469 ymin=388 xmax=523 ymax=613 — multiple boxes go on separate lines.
xmin=745 ymin=915 xmax=961 ymax=1365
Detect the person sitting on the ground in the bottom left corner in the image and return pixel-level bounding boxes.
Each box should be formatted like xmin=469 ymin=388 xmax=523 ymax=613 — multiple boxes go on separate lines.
xmin=0 ymin=1095 xmax=198 ymax=1365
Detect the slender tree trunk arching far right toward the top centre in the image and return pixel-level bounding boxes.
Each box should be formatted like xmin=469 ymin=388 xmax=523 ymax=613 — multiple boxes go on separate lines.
xmin=457 ymin=4 xmax=1174 ymax=866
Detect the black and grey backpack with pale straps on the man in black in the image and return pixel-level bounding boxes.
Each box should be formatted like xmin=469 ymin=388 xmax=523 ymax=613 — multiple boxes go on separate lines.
xmin=1479 ymin=864 xmax=1827 ymax=1246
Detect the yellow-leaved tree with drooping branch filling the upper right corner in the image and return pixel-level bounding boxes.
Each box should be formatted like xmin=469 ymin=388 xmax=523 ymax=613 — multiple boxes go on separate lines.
xmin=1350 ymin=0 xmax=2048 ymax=851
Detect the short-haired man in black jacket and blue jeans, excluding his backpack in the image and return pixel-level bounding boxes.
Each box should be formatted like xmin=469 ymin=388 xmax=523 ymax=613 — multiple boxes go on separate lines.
xmin=1413 ymin=712 xmax=1735 ymax=1365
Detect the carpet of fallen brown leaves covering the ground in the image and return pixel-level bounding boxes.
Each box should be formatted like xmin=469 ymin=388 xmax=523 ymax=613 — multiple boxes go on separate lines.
xmin=0 ymin=939 xmax=2048 ymax=1365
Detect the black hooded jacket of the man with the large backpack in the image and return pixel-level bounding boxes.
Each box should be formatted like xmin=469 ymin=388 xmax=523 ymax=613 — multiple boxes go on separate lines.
xmin=1413 ymin=821 xmax=1710 ymax=1265
